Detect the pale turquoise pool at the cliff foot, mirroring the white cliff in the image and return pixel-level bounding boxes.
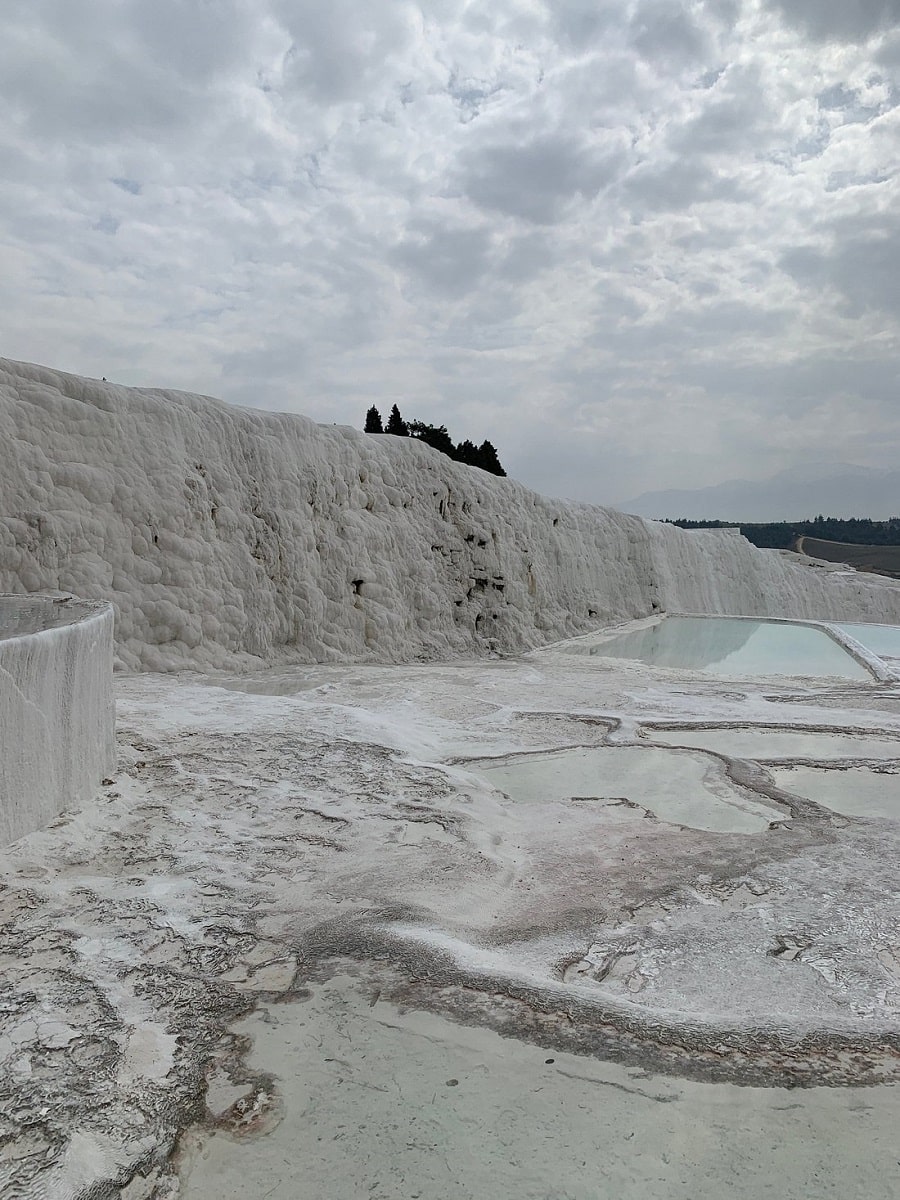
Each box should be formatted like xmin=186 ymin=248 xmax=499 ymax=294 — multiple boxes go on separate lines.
xmin=566 ymin=617 xmax=871 ymax=679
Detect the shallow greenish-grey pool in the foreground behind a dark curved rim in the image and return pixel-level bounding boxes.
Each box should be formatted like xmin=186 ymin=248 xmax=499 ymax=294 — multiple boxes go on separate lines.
xmin=174 ymin=976 xmax=900 ymax=1200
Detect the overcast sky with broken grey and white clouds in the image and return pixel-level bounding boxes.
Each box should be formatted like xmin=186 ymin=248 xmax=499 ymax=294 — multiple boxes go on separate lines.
xmin=0 ymin=0 xmax=900 ymax=503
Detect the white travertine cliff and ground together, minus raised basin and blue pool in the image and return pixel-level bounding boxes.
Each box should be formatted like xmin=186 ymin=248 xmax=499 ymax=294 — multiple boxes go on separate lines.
xmin=0 ymin=362 xmax=900 ymax=1200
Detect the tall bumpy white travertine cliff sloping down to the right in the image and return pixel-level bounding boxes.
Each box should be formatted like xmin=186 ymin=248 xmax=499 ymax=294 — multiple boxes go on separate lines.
xmin=0 ymin=360 xmax=900 ymax=670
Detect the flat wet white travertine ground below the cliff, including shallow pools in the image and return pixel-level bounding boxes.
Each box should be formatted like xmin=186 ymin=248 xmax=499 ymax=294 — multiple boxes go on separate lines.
xmin=0 ymin=633 xmax=900 ymax=1200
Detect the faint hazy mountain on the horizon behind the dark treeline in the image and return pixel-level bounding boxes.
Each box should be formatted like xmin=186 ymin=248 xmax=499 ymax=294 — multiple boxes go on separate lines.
xmin=617 ymin=462 xmax=900 ymax=521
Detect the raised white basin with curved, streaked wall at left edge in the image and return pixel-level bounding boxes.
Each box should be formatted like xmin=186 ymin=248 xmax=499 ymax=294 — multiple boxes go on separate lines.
xmin=0 ymin=595 xmax=115 ymax=845
